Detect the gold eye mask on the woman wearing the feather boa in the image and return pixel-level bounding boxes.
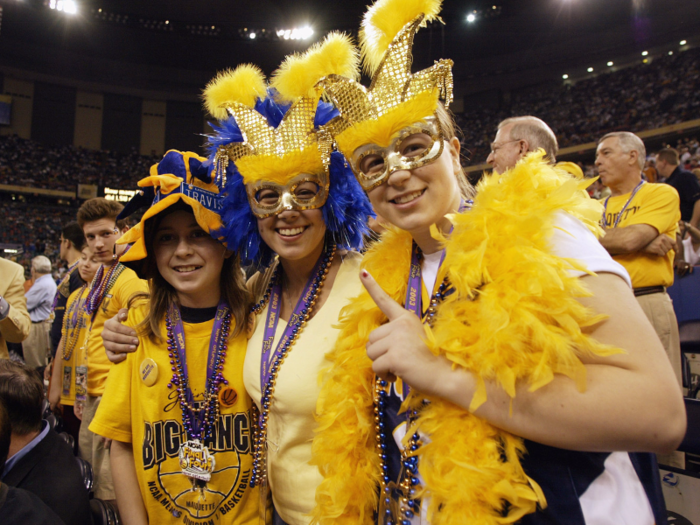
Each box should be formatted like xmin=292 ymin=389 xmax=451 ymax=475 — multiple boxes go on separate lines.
xmin=350 ymin=117 xmax=444 ymax=191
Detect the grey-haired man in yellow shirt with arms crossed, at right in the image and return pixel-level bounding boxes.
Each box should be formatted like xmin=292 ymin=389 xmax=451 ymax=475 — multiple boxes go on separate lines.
xmin=595 ymin=131 xmax=684 ymax=467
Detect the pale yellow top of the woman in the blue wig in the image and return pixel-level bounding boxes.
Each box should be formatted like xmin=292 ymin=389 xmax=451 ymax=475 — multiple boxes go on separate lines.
xmin=243 ymin=253 xmax=362 ymax=525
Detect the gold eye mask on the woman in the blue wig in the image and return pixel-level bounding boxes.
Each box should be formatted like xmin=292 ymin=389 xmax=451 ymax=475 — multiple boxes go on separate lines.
xmin=246 ymin=172 xmax=330 ymax=219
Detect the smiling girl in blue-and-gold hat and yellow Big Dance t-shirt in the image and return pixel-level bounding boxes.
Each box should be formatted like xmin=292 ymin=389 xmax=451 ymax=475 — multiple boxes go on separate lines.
xmin=90 ymin=150 xmax=259 ymax=525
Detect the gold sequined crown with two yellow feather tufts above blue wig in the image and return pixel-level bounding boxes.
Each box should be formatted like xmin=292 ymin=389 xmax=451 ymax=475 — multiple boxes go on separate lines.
xmin=204 ymin=33 xmax=359 ymax=184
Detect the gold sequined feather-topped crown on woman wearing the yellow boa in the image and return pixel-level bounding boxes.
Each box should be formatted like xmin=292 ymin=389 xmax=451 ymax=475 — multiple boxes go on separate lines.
xmin=321 ymin=0 xmax=453 ymax=157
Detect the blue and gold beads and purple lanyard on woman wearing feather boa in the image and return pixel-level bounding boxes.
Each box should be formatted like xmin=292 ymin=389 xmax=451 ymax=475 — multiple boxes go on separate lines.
xmin=374 ymin=242 xmax=450 ymax=525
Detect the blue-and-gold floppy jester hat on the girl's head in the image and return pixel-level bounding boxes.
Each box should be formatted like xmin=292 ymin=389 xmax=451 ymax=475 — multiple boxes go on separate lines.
xmin=117 ymin=150 xmax=224 ymax=279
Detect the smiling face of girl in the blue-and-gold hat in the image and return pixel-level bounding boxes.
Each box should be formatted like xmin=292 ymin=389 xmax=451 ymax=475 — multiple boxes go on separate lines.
xmin=153 ymin=210 xmax=231 ymax=308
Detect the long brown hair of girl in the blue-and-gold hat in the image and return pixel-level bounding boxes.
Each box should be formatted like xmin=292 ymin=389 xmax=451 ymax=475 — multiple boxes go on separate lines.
xmin=129 ymin=203 xmax=252 ymax=343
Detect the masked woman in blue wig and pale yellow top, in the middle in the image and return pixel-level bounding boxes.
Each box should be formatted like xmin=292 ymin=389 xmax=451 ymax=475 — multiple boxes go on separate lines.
xmin=103 ymin=34 xmax=372 ymax=525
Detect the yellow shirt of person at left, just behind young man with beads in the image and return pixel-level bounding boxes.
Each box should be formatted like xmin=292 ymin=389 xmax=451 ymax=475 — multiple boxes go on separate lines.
xmin=60 ymin=286 xmax=90 ymax=406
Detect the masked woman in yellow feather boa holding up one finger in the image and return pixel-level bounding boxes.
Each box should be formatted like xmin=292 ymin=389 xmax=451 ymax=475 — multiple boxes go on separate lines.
xmin=313 ymin=0 xmax=685 ymax=525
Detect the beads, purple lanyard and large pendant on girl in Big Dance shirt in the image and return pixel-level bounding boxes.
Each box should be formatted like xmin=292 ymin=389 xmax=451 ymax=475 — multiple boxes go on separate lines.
xmin=165 ymin=301 xmax=231 ymax=490
